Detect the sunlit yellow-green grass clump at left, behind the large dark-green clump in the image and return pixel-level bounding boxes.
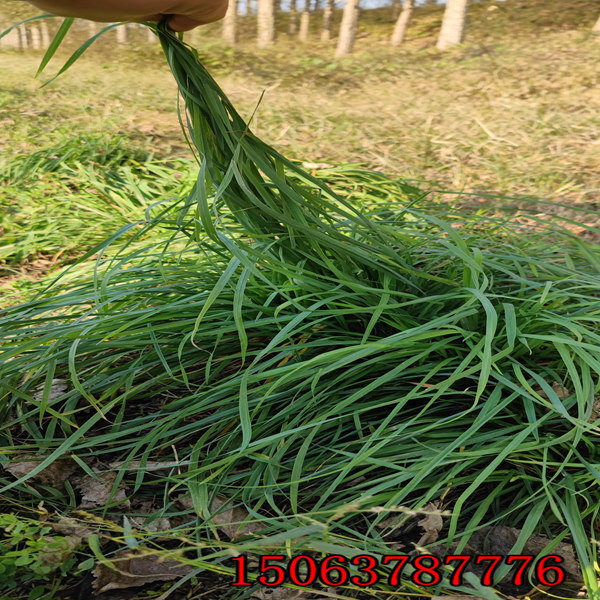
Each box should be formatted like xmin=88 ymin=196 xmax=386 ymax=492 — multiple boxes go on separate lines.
xmin=0 ymin=136 xmax=195 ymax=273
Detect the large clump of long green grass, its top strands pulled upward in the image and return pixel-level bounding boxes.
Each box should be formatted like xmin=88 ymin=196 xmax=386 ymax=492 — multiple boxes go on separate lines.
xmin=0 ymin=21 xmax=600 ymax=598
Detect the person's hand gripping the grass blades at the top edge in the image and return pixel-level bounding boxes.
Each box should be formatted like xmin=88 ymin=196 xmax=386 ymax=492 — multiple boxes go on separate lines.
xmin=28 ymin=0 xmax=227 ymax=31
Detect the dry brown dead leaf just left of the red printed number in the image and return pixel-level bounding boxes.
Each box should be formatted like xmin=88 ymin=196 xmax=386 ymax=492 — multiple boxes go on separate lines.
xmin=93 ymin=550 xmax=194 ymax=594
